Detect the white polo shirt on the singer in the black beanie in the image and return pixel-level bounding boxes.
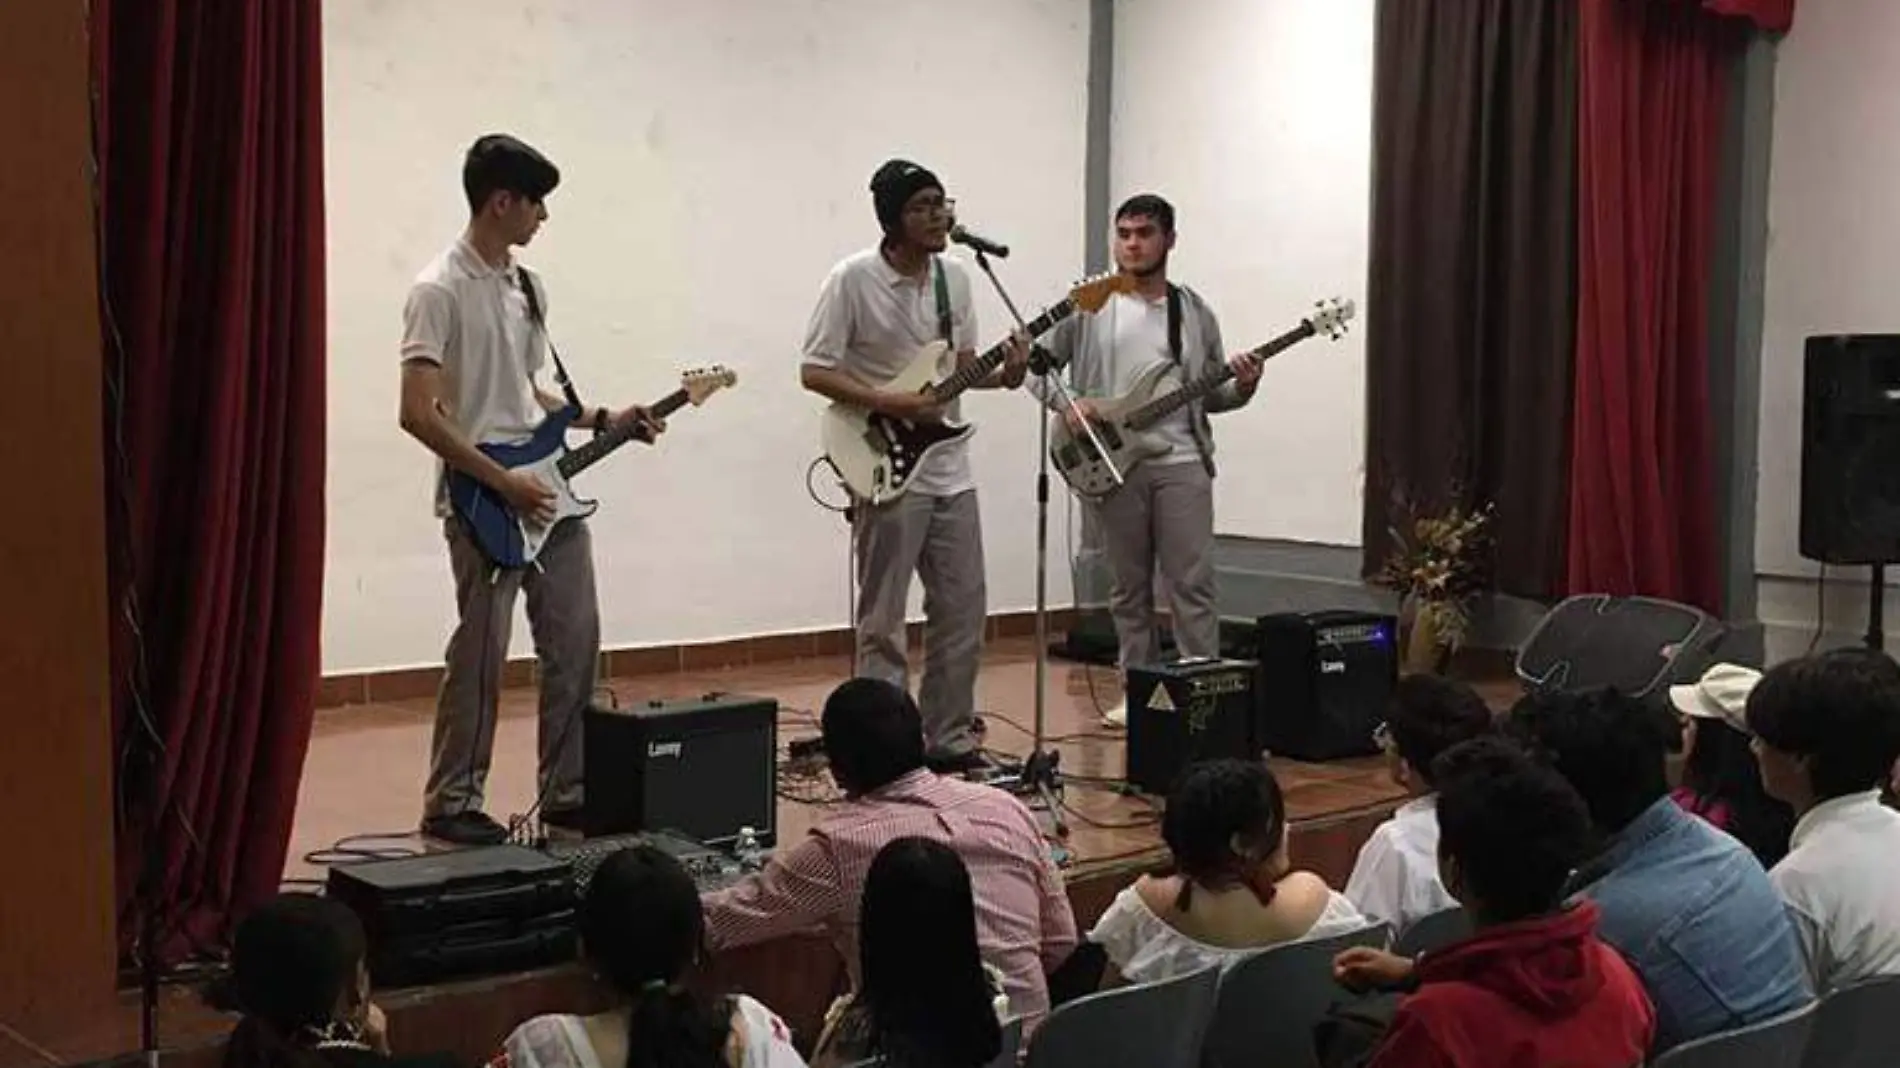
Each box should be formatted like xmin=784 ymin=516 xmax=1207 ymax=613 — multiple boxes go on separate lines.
xmin=804 ymin=249 xmax=977 ymax=496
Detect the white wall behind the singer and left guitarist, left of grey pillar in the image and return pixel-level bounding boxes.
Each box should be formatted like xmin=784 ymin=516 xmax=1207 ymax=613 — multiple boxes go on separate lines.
xmin=323 ymin=0 xmax=1089 ymax=673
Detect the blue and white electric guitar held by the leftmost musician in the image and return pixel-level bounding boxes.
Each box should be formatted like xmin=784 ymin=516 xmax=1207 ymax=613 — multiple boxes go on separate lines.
xmin=448 ymin=365 xmax=739 ymax=568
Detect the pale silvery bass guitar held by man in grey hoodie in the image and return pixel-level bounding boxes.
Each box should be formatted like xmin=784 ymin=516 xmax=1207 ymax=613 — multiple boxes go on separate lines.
xmin=1049 ymin=298 xmax=1353 ymax=500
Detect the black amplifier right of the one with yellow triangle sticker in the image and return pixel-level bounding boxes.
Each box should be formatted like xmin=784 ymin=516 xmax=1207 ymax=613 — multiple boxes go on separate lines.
xmin=1241 ymin=610 xmax=1398 ymax=760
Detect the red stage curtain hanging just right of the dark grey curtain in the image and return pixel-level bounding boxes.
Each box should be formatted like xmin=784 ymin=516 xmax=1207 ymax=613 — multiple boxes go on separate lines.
xmin=1566 ymin=0 xmax=1744 ymax=612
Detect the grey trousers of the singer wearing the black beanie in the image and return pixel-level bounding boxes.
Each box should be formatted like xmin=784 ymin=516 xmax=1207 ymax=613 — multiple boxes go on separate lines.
xmin=851 ymin=490 xmax=988 ymax=756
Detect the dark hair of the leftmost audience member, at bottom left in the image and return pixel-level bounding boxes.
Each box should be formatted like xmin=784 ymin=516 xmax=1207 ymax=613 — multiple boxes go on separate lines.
xmin=207 ymin=893 xmax=369 ymax=1068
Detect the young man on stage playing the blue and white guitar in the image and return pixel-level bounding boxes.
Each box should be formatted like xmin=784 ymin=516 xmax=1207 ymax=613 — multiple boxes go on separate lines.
xmin=401 ymin=135 xmax=663 ymax=846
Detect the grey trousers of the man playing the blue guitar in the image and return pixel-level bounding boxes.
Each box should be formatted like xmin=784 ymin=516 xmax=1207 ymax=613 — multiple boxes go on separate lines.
xmin=422 ymin=519 xmax=600 ymax=817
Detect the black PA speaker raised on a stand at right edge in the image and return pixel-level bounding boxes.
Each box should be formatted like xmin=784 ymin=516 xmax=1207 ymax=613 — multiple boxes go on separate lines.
xmin=1801 ymin=334 xmax=1900 ymax=564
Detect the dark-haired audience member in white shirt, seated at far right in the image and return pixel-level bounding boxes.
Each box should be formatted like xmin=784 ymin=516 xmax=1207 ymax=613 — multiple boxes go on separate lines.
xmin=1748 ymin=650 xmax=1900 ymax=994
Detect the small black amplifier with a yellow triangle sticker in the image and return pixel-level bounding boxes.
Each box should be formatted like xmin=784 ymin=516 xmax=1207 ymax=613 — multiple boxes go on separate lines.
xmin=1129 ymin=659 xmax=1260 ymax=794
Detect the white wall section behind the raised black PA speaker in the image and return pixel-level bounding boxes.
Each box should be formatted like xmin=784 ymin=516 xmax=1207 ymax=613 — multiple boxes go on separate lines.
xmin=1756 ymin=0 xmax=1900 ymax=656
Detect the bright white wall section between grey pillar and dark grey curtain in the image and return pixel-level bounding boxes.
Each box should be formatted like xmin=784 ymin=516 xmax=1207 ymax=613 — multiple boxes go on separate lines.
xmin=1112 ymin=0 xmax=1374 ymax=545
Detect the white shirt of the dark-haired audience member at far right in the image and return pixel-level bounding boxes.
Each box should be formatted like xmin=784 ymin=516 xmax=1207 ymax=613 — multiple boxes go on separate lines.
xmin=1769 ymin=791 xmax=1900 ymax=994
